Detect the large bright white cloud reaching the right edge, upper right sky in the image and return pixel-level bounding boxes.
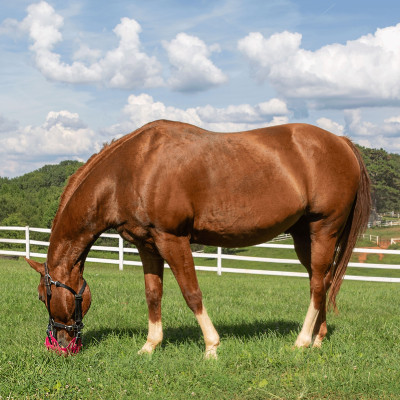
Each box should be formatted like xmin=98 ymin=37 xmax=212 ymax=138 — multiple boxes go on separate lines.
xmin=238 ymin=24 xmax=400 ymax=108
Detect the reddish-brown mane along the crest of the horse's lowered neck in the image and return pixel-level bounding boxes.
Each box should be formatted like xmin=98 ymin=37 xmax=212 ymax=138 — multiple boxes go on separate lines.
xmin=52 ymin=123 xmax=159 ymax=230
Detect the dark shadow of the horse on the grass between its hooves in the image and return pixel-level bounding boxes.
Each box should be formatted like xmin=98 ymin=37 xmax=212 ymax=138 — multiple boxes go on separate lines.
xmin=84 ymin=320 xmax=335 ymax=347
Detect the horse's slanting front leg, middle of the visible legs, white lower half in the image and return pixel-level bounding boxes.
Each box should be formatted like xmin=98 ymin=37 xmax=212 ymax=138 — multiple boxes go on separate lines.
xmin=156 ymin=233 xmax=219 ymax=358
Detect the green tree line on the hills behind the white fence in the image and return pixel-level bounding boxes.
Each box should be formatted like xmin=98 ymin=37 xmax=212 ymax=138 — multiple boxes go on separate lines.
xmin=0 ymin=146 xmax=400 ymax=228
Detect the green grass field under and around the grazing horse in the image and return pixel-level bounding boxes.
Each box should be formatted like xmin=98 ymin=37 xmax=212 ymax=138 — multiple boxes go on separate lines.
xmin=0 ymin=260 xmax=400 ymax=400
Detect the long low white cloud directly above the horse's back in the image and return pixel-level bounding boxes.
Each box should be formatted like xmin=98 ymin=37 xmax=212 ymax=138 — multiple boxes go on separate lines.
xmin=112 ymin=93 xmax=289 ymax=133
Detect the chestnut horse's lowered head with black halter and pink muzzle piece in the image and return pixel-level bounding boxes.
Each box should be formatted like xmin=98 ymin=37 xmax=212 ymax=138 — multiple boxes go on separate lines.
xmin=26 ymin=259 xmax=91 ymax=353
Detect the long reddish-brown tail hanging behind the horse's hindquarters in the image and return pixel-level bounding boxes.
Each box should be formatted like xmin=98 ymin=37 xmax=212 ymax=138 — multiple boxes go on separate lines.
xmin=328 ymin=137 xmax=371 ymax=309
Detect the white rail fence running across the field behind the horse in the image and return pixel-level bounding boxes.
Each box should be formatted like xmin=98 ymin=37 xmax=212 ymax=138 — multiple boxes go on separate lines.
xmin=0 ymin=226 xmax=400 ymax=283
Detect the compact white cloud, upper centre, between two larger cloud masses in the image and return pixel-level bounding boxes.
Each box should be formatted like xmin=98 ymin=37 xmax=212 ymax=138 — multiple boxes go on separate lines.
xmin=163 ymin=33 xmax=228 ymax=92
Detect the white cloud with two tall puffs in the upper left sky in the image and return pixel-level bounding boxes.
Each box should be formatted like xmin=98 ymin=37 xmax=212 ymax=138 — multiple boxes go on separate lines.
xmin=2 ymin=1 xmax=163 ymax=89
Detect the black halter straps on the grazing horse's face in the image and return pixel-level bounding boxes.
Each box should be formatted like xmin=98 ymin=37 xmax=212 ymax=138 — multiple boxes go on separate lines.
xmin=44 ymin=262 xmax=86 ymax=341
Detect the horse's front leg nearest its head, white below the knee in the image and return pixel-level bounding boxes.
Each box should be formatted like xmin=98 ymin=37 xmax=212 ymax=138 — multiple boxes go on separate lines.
xmin=138 ymin=247 xmax=164 ymax=354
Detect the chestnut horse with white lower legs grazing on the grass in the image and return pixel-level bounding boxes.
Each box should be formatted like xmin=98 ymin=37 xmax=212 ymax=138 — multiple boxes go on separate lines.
xmin=27 ymin=120 xmax=371 ymax=358
